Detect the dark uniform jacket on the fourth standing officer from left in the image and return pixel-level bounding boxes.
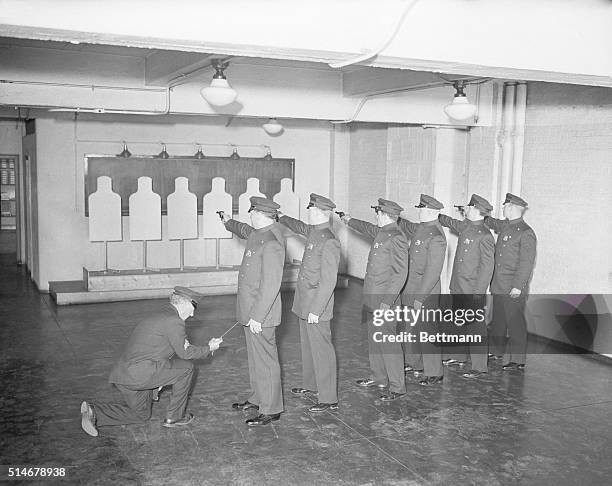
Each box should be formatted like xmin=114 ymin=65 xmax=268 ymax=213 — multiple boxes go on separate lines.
xmin=398 ymin=219 xmax=446 ymax=306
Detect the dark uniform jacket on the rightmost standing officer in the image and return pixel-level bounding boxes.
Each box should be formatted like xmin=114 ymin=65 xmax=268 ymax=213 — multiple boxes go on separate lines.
xmin=485 ymin=217 xmax=537 ymax=295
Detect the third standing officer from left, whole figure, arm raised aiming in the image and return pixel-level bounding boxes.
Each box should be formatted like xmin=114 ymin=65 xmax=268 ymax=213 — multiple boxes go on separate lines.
xmin=342 ymin=198 xmax=408 ymax=401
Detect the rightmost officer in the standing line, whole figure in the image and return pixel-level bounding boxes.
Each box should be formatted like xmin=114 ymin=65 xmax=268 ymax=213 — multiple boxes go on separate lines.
xmin=485 ymin=193 xmax=537 ymax=370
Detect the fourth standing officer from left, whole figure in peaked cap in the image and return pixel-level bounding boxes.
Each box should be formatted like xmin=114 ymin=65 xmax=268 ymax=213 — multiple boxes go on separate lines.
xmin=398 ymin=194 xmax=446 ymax=386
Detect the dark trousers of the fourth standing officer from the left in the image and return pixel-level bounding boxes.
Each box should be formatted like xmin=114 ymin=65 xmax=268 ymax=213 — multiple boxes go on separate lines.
xmin=405 ymin=294 xmax=444 ymax=377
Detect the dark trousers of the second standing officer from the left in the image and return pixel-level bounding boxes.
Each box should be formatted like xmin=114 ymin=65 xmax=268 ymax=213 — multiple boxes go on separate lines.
xmin=299 ymin=319 xmax=338 ymax=403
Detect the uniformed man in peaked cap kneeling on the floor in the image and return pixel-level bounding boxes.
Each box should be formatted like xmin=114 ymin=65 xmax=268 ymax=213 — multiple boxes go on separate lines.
xmin=81 ymin=287 xmax=223 ymax=437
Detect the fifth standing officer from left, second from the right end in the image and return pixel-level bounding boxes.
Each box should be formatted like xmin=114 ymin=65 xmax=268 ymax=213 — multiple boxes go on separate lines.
xmin=438 ymin=194 xmax=495 ymax=378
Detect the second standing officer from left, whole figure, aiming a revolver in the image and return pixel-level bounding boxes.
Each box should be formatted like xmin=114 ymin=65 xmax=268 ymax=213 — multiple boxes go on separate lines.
xmin=279 ymin=193 xmax=340 ymax=412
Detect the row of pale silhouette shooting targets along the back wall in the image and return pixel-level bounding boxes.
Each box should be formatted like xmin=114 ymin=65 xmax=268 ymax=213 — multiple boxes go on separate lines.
xmin=88 ymin=176 xmax=300 ymax=241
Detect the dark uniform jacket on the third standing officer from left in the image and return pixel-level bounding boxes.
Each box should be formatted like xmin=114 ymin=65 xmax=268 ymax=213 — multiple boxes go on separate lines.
xmin=348 ymin=218 xmax=408 ymax=310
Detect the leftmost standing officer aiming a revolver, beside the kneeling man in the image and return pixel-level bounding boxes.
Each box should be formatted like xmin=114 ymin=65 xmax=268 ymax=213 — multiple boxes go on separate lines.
xmin=221 ymin=196 xmax=285 ymax=426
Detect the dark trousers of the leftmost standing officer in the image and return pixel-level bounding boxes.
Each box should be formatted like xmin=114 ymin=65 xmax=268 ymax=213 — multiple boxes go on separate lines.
xmin=244 ymin=327 xmax=283 ymax=415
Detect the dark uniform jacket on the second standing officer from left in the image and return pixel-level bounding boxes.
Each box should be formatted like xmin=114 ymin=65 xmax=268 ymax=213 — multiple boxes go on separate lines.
xmin=279 ymin=216 xmax=340 ymax=321
